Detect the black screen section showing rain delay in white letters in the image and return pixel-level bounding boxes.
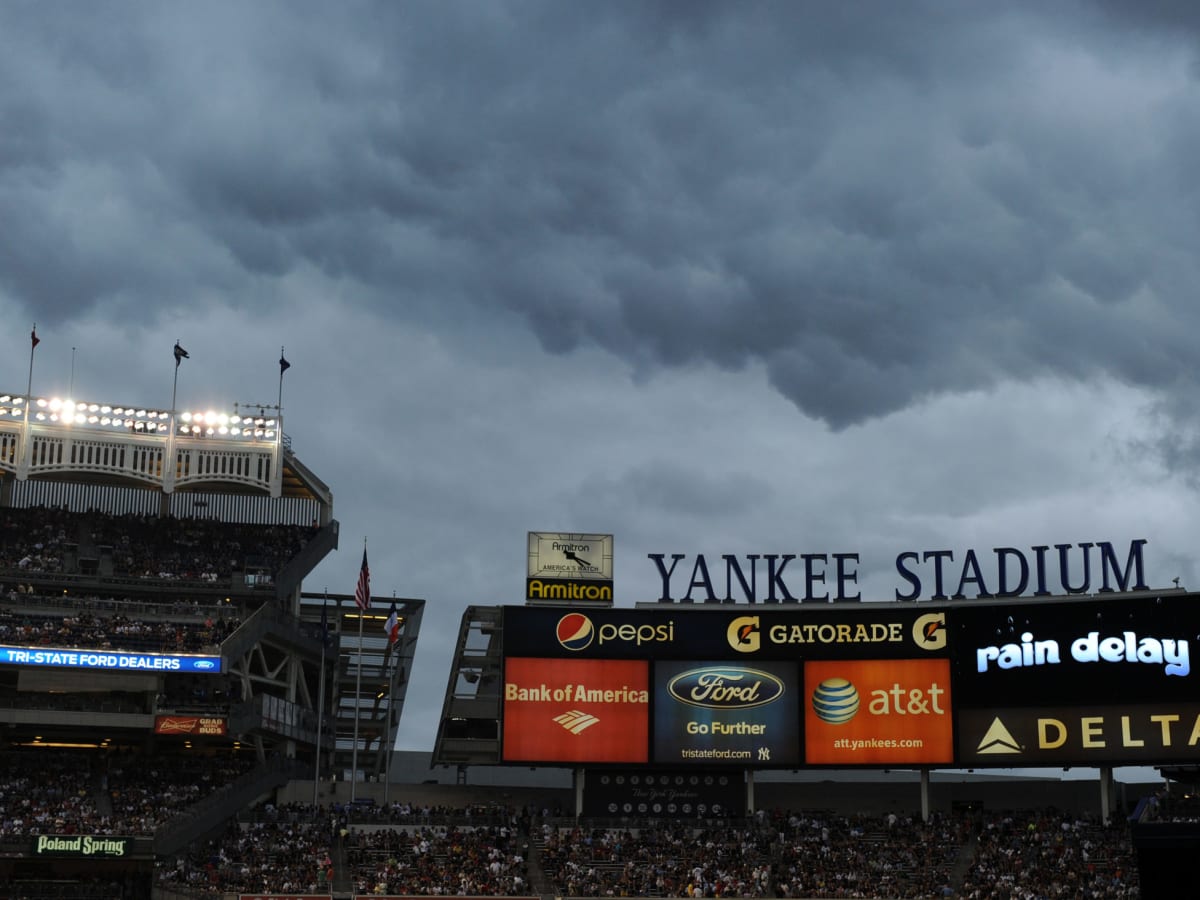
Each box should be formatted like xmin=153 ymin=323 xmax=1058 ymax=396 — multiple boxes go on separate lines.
xmin=950 ymin=594 xmax=1200 ymax=709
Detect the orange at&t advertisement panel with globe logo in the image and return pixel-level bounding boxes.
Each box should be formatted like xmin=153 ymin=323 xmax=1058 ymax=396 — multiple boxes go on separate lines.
xmin=804 ymin=659 xmax=954 ymax=766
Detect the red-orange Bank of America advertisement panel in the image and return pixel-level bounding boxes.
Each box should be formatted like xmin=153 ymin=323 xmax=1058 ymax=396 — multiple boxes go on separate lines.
xmin=502 ymin=658 xmax=650 ymax=763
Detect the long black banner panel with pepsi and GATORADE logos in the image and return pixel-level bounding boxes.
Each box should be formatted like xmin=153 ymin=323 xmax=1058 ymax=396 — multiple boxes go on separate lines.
xmin=504 ymin=604 xmax=949 ymax=660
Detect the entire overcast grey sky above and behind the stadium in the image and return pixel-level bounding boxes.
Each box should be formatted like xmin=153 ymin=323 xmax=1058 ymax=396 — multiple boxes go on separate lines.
xmin=0 ymin=0 xmax=1200 ymax=772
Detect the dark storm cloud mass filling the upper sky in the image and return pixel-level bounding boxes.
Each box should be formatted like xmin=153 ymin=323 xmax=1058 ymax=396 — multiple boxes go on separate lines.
xmin=0 ymin=2 xmax=1200 ymax=436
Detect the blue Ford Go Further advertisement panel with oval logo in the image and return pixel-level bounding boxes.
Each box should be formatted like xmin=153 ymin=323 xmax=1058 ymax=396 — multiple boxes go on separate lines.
xmin=654 ymin=660 xmax=800 ymax=768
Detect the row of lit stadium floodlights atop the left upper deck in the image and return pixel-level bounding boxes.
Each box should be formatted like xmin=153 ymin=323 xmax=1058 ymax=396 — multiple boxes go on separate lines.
xmin=0 ymin=394 xmax=278 ymax=440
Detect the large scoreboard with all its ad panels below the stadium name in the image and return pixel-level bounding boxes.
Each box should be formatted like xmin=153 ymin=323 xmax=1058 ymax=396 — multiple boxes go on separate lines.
xmin=502 ymin=594 xmax=1200 ymax=772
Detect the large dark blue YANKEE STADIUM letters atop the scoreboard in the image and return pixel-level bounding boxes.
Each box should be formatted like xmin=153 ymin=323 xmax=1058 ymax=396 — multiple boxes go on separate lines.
xmin=646 ymin=539 xmax=1150 ymax=604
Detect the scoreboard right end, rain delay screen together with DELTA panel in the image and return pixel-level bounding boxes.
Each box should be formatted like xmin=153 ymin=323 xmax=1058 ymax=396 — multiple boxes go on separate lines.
xmin=950 ymin=594 xmax=1200 ymax=767
